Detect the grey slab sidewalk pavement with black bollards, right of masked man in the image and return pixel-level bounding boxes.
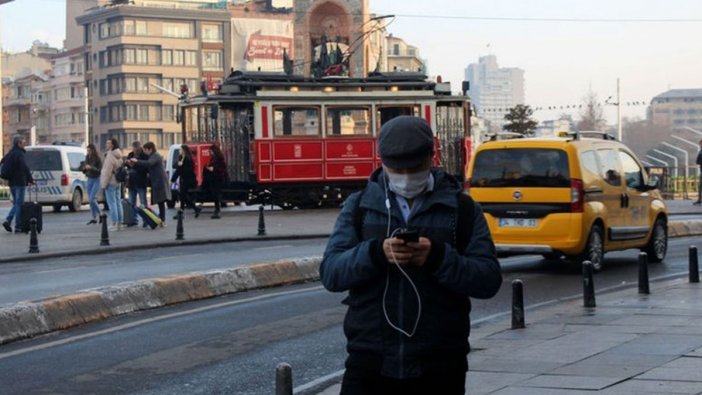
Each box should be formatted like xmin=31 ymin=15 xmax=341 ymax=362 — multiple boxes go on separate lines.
xmin=320 ymin=279 xmax=702 ymax=395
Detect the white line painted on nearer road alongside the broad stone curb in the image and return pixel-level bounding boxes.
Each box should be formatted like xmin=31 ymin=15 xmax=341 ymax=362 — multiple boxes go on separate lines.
xmin=0 ymin=285 xmax=324 ymax=360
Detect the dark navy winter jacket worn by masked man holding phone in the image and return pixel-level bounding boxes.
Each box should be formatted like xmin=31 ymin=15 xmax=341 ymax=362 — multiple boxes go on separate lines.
xmin=320 ymin=169 xmax=502 ymax=378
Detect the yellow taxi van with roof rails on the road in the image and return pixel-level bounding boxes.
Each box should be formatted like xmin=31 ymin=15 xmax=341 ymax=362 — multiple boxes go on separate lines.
xmin=466 ymin=132 xmax=668 ymax=271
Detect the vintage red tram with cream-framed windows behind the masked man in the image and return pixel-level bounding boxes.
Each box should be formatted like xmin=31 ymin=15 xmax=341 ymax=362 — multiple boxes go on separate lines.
xmin=181 ymin=71 xmax=471 ymax=208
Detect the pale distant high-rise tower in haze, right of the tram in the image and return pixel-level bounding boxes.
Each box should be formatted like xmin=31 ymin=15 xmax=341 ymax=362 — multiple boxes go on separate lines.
xmin=465 ymin=55 xmax=524 ymax=132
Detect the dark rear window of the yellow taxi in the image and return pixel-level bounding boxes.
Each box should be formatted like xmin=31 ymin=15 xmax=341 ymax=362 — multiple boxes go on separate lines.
xmin=471 ymin=148 xmax=570 ymax=188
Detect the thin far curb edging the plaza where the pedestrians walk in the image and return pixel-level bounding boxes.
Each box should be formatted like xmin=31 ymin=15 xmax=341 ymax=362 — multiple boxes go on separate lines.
xmin=0 ymin=233 xmax=330 ymax=264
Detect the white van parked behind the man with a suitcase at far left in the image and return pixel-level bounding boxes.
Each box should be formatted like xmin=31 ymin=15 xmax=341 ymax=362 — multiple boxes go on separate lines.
xmin=25 ymin=145 xmax=88 ymax=211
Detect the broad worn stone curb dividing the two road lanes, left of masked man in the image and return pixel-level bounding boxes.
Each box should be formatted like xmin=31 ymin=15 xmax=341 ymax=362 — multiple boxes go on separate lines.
xmin=0 ymin=257 xmax=321 ymax=344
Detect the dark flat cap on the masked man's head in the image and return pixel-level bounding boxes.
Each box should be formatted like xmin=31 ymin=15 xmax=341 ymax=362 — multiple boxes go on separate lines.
xmin=378 ymin=115 xmax=434 ymax=169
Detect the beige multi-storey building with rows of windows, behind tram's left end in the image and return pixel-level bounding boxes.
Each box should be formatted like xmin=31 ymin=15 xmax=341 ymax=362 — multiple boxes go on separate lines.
xmin=77 ymin=0 xmax=231 ymax=148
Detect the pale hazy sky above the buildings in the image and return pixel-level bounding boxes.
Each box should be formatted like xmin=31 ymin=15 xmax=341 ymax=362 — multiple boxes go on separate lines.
xmin=0 ymin=0 xmax=702 ymax=123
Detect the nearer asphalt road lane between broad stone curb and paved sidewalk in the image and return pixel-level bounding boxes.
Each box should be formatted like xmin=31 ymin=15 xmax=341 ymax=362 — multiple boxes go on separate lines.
xmin=0 ymin=237 xmax=702 ymax=394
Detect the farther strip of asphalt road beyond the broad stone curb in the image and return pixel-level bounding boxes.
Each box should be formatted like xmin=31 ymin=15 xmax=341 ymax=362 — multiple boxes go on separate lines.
xmin=0 ymin=239 xmax=326 ymax=305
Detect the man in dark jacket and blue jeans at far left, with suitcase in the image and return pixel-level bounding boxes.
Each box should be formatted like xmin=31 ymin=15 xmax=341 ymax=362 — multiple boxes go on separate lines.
xmin=1 ymin=134 xmax=34 ymax=233
